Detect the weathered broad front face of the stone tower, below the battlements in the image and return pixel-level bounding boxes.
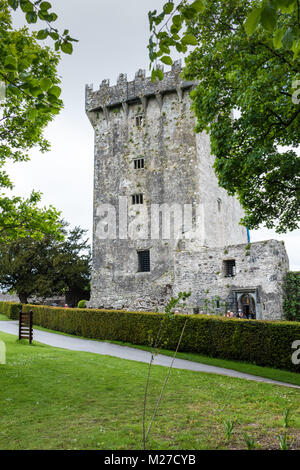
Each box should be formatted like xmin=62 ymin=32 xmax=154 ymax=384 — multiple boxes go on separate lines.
xmin=91 ymin=82 xmax=198 ymax=310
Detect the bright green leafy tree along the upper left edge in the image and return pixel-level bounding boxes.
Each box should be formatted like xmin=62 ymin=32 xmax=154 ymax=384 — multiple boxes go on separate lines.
xmin=0 ymin=0 xmax=74 ymax=239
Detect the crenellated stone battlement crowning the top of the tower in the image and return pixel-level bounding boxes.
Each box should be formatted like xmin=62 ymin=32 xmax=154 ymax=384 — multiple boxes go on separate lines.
xmin=86 ymin=60 xmax=195 ymax=112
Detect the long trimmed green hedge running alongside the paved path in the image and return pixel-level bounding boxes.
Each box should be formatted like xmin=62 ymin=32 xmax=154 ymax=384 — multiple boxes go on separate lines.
xmin=0 ymin=303 xmax=300 ymax=372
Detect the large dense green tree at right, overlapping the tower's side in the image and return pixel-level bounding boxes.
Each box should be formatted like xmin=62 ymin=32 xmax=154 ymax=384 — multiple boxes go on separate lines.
xmin=149 ymin=0 xmax=300 ymax=232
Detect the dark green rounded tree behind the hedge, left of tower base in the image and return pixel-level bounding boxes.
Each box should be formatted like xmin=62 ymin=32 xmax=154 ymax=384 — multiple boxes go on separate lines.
xmin=0 ymin=222 xmax=91 ymax=303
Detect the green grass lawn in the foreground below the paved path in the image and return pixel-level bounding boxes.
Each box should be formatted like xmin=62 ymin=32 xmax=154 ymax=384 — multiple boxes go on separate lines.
xmin=0 ymin=332 xmax=300 ymax=450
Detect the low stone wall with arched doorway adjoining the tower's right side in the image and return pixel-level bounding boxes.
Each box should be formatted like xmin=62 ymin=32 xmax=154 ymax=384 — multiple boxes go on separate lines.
xmin=174 ymin=240 xmax=289 ymax=320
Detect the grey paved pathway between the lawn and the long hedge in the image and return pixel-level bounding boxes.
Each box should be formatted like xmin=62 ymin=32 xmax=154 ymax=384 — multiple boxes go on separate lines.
xmin=0 ymin=321 xmax=300 ymax=390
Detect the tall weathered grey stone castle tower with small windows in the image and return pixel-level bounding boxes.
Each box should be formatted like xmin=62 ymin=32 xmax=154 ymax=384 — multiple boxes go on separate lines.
xmin=86 ymin=62 xmax=287 ymax=317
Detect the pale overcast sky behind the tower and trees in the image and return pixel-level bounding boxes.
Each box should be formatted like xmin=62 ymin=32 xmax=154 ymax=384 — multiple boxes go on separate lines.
xmin=7 ymin=0 xmax=300 ymax=270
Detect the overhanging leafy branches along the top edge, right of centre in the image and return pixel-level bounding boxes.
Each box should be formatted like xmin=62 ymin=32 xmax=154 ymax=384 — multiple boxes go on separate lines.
xmin=148 ymin=0 xmax=300 ymax=81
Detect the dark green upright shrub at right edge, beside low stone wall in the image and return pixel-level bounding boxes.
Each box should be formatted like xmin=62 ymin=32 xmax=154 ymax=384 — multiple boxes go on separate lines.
xmin=283 ymin=271 xmax=300 ymax=321
